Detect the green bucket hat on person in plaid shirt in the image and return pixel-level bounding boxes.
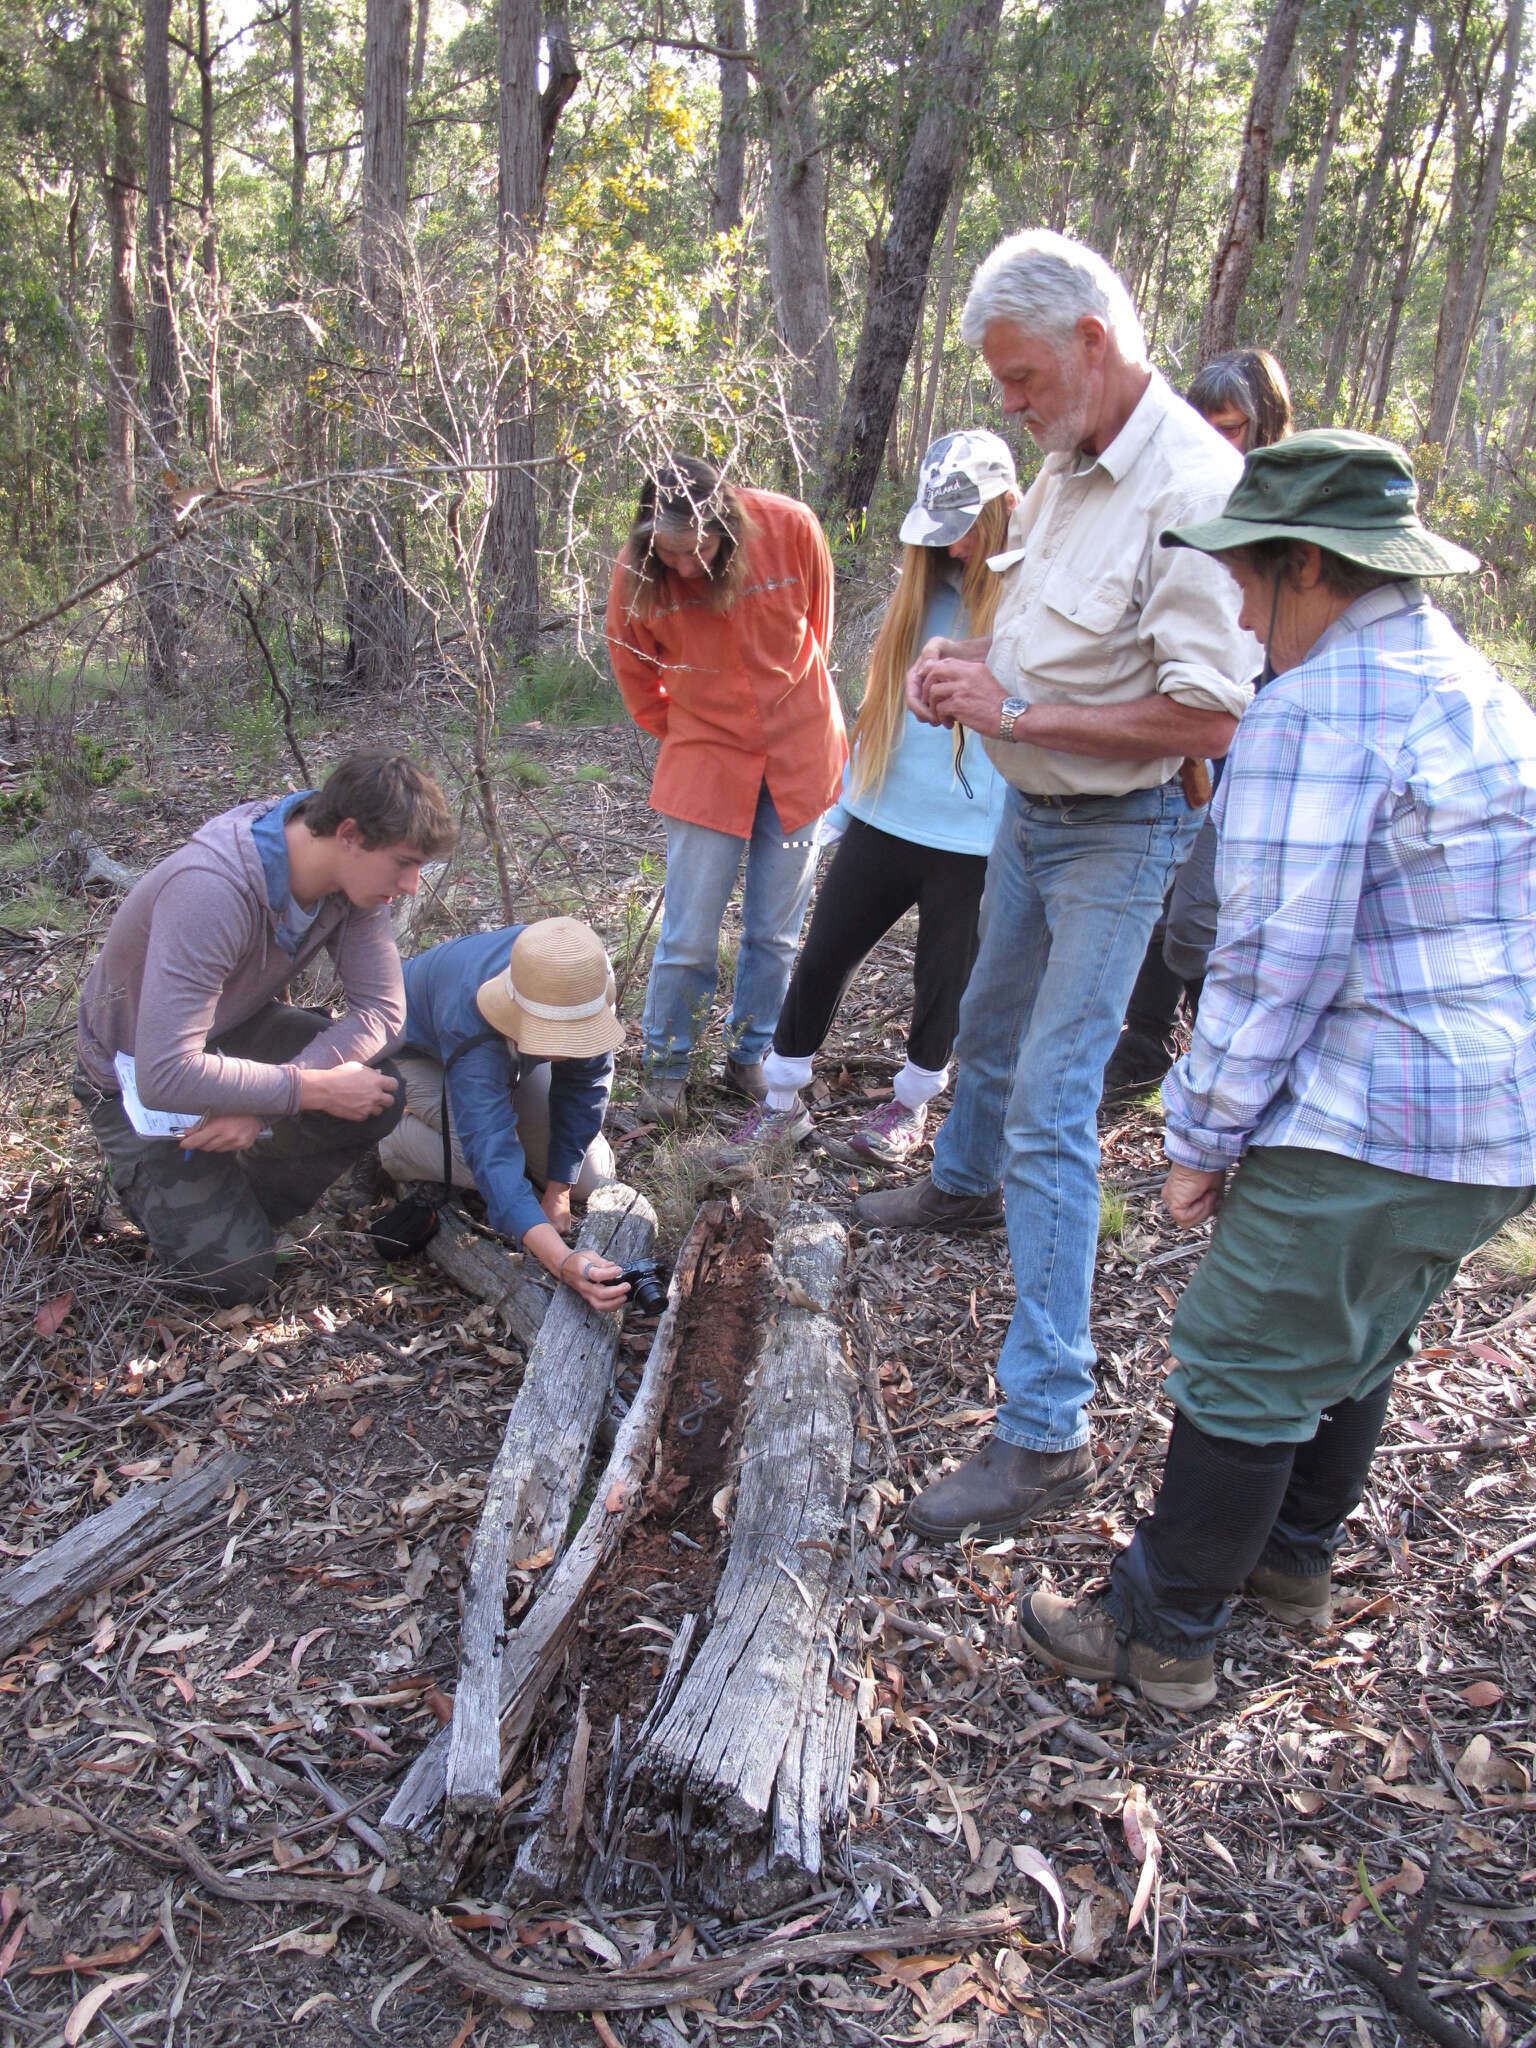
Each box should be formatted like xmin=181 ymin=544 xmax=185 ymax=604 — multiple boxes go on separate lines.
xmin=1163 ymin=426 xmax=1477 ymax=575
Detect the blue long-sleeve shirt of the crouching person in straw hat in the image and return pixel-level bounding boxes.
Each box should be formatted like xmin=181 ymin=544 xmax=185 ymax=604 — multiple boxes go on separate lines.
xmin=401 ymin=924 xmax=612 ymax=1243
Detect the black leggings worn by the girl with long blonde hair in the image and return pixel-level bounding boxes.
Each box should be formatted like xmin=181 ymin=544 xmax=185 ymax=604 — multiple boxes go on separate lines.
xmin=774 ymin=817 xmax=987 ymax=1071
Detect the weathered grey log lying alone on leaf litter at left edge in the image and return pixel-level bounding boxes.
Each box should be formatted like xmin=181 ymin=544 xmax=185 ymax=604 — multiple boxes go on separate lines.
xmin=0 ymin=1450 xmax=250 ymax=1657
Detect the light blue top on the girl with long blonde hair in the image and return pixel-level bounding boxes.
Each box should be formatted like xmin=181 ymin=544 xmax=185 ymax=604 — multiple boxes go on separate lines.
xmin=827 ymin=582 xmax=1008 ymax=856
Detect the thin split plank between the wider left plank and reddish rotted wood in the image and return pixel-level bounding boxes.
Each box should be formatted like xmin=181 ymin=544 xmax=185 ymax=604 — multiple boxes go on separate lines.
xmin=379 ymin=1202 xmax=727 ymax=1901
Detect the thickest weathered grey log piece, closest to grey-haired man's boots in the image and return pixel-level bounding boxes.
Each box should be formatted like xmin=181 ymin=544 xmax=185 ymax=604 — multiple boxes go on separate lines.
xmin=641 ymin=1204 xmax=856 ymax=1837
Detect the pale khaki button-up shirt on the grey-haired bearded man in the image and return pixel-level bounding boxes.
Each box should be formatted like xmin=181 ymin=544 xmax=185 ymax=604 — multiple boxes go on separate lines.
xmin=985 ymin=373 xmax=1264 ymax=797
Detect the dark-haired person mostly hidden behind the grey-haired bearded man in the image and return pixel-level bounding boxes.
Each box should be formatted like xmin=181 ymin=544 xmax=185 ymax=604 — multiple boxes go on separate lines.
xmin=1104 ymin=348 xmax=1290 ymax=1098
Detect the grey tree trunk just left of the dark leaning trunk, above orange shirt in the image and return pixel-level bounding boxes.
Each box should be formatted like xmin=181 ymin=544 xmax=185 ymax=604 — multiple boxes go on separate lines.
xmin=756 ymin=0 xmax=838 ymax=442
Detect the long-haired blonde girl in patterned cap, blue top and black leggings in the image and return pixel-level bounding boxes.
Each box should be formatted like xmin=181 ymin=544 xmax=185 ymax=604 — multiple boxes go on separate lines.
xmin=731 ymin=428 xmax=1018 ymax=1165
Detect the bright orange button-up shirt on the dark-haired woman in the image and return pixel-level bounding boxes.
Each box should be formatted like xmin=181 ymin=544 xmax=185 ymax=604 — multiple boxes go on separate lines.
xmin=608 ymin=492 xmax=848 ymax=840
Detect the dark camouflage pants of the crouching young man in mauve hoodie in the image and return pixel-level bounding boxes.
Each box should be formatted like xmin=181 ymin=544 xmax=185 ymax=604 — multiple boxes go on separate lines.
xmin=74 ymin=1004 xmax=403 ymax=1309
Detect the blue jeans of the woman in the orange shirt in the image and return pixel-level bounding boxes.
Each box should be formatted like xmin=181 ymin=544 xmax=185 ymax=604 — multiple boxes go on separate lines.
xmin=641 ymin=782 xmax=815 ymax=1079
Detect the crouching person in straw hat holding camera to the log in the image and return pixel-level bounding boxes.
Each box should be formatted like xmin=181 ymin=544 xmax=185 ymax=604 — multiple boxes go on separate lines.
xmin=379 ymin=918 xmax=627 ymax=1309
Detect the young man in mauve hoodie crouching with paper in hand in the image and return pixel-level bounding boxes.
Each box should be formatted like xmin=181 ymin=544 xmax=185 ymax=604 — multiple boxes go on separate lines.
xmin=74 ymin=752 xmax=455 ymax=1307
